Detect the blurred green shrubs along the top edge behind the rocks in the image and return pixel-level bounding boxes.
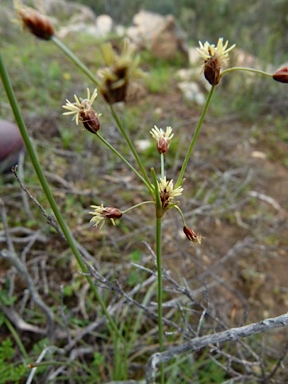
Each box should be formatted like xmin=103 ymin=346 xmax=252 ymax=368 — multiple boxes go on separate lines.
xmin=69 ymin=0 xmax=288 ymax=63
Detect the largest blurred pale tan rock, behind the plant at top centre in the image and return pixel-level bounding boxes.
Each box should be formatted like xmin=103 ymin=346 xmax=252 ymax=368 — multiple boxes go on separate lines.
xmin=127 ymin=11 xmax=188 ymax=62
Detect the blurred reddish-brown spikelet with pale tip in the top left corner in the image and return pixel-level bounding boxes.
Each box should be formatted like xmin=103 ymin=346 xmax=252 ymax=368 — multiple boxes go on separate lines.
xmin=15 ymin=2 xmax=55 ymax=40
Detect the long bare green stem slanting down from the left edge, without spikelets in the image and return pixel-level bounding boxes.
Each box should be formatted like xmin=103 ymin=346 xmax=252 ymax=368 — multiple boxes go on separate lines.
xmin=0 ymin=54 xmax=125 ymax=343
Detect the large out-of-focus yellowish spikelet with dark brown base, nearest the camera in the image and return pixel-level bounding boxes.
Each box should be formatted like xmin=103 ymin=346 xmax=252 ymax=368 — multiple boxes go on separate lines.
xmin=99 ymin=39 xmax=142 ymax=104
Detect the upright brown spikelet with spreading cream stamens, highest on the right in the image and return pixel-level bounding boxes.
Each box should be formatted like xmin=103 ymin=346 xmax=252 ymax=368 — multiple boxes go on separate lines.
xmin=197 ymin=37 xmax=235 ymax=85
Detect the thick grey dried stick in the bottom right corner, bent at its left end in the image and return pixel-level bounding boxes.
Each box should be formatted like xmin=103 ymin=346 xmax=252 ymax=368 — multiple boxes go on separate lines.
xmin=145 ymin=314 xmax=288 ymax=384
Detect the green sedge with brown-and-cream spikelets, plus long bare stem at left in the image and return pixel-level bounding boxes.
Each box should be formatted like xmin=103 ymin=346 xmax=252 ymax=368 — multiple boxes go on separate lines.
xmin=0 ymin=3 xmax=288 ymax=384
